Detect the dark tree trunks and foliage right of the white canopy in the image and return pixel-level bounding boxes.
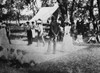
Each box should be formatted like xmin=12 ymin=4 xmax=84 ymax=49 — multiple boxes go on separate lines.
xmin=57 ymin=0 xmax=100 ymax=24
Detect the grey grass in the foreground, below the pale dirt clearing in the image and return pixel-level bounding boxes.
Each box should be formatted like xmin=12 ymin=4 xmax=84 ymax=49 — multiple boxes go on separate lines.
xmin=0 ymin=45 xmax=100 ymax=73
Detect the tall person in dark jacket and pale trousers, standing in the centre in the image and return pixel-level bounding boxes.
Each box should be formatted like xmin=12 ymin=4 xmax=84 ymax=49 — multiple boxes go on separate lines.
xmin=47 ymin=16 xmax=60 ymax=54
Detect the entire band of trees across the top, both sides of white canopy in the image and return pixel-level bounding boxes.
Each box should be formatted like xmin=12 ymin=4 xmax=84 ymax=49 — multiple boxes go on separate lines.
xmin=0 ymin=0 xmax=100 ymax=24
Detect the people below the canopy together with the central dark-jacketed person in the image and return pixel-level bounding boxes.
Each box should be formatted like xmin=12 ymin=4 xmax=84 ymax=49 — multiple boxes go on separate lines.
xmin=24 ymin=16 xmax=65 ymax=53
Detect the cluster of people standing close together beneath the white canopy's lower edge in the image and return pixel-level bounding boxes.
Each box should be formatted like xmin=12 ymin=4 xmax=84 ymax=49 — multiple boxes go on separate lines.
xmin=26 ymin=19 xmax=45 ymax=46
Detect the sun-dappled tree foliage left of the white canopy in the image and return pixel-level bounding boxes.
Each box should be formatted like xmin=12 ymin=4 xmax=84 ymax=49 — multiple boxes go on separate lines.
xmin=0 ymin=0 xmax=39 ymax=23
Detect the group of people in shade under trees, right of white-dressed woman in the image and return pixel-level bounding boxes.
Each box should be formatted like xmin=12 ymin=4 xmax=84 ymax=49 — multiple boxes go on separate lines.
xmin=71 ymin=19 xmax=100 ymax=43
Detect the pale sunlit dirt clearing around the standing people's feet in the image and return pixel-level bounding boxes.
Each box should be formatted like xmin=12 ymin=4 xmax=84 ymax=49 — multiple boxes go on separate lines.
xmin=12 ymin=35 xmax=86 ymax=63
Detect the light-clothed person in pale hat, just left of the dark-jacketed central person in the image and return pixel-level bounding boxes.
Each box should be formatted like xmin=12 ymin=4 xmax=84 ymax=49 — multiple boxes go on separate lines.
xmin=36 ymin=19 xmax=45 ymax=46
